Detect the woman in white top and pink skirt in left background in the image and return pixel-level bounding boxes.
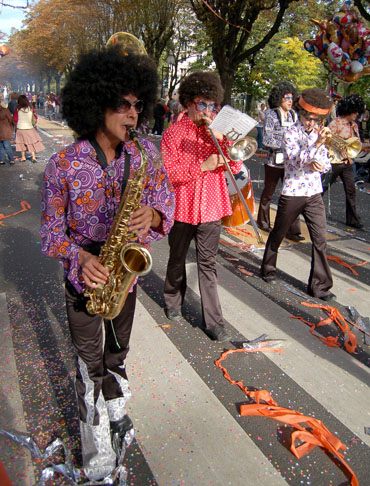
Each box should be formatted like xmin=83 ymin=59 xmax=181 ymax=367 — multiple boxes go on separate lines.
xmin=14 ymin=95 xmax=45 ymax=162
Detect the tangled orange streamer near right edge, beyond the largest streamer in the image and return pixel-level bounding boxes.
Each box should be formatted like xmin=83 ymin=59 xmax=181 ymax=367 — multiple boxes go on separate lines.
xmin=290 ymin=302 xmax=358 ymax=354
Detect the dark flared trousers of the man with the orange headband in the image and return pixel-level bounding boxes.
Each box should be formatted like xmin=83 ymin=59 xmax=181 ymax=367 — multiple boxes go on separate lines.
xmin=261 ymin=194 xmax=333 ymax=297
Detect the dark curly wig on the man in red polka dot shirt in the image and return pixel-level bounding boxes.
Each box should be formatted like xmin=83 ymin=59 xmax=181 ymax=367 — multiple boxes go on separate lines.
xmin=179 ymin=71 xmax=224 ymax=108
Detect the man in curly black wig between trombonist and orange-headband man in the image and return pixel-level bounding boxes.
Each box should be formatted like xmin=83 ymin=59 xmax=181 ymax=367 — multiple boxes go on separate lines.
xmin=257 ymin=81 xmax=304 ymax=241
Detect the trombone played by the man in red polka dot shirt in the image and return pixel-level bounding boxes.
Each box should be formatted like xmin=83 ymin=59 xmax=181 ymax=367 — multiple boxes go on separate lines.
xmin=208 ymin=126 xmax=264 ymax=245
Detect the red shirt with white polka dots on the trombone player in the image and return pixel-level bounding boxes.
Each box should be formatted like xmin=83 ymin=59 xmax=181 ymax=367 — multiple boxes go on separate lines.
xmin=161 ymin=115 xmax=243 ymax=225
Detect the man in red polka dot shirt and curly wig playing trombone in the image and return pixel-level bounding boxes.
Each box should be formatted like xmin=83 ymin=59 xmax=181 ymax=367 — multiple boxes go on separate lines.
xmin=162 ymin=71 xmax=243 ymax=341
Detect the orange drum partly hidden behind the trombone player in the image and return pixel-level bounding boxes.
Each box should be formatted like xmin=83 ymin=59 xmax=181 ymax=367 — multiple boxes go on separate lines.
xmin=222 ymin=165 xmax=256 ymax=228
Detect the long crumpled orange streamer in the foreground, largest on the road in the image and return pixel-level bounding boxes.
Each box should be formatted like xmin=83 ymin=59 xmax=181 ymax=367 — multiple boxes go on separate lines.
xmin=215 ymin=346 xmax=359 ymax=486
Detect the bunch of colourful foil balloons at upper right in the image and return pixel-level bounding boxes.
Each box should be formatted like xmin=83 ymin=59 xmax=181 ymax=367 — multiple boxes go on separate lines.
xmin=304 ymin=1 xmax=370 ymax=83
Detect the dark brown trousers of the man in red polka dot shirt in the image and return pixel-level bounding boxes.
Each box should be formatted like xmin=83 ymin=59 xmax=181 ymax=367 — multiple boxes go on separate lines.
xmin=164 ymin=221 xmax=225 ymax=329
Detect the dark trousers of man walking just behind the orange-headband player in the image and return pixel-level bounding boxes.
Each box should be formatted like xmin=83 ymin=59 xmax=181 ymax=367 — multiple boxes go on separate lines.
xmin=257 ymin=164 xmax=301 ymax=236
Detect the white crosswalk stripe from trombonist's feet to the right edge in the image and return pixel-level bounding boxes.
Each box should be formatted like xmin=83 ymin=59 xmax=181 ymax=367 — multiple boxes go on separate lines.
xmin=186 ymin=264 xmax=370 ymax=445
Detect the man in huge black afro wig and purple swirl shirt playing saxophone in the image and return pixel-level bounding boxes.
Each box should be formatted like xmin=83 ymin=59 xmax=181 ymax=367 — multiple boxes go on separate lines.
xmin=40 ymin=46 xmax=174 ymax=484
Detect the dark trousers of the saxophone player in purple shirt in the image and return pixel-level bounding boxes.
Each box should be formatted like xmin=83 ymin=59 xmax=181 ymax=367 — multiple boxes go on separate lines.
xmin=66 ymin=285 xmax=136 ymax=425
